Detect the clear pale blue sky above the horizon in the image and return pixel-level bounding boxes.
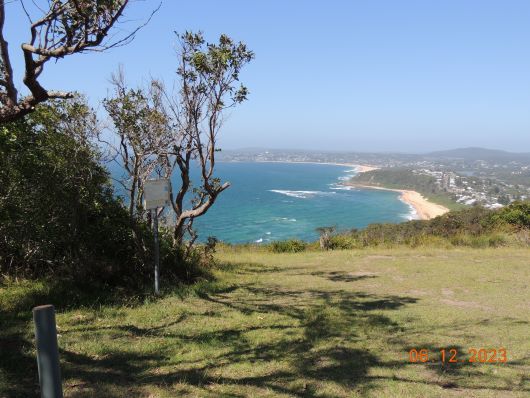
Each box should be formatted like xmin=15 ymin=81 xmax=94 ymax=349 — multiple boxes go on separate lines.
xmin=5 ymin=0 xmax=530 ymax=153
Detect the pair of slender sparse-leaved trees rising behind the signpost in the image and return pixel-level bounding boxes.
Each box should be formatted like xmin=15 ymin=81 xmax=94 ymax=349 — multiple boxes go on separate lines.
xmin=106 ymin=32 xmax=254 ymax=247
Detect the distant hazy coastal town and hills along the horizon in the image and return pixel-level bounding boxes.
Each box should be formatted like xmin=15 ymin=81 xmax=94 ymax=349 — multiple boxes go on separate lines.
xmin=220 ymin=148 xmax=530 ymax=209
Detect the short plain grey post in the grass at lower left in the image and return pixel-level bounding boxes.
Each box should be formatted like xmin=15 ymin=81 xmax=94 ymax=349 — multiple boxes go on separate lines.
xmin=33 ymin=305 xmax=63 ymax=398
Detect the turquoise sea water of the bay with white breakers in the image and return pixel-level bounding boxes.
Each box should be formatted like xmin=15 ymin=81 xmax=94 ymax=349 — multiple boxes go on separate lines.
xmin=188 ymin=163 xmax=413 ymax=243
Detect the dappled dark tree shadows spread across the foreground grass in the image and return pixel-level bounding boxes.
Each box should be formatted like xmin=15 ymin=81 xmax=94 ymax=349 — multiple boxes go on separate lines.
xmin=0 ymin=264 xmax=528 ymax=397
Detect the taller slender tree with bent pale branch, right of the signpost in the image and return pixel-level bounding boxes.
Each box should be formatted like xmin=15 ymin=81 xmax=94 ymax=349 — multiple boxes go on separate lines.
xmin=169 ymin=32 xmax=254 ymax=245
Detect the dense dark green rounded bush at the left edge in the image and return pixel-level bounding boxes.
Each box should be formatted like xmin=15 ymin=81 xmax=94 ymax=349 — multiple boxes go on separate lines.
xmin=0 ymin=98 xmax=146 ymax=282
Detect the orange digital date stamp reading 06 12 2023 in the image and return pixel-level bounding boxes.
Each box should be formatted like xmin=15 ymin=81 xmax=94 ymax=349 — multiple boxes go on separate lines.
xmin=409 ymin=348 xmax=508 ymax=364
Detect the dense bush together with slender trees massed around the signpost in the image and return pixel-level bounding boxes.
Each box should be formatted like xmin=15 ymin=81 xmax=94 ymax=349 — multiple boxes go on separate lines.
xmin=0 ymin=32 xmax=253 ymax=291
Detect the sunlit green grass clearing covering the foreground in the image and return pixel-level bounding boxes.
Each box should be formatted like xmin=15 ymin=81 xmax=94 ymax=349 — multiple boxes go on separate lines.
xmin=0 ymin=248 xmax=530 ymax=397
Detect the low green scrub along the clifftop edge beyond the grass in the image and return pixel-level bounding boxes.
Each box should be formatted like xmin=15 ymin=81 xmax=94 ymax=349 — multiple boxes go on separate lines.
xmin=262 ymin=202 xmax=530 ymax=253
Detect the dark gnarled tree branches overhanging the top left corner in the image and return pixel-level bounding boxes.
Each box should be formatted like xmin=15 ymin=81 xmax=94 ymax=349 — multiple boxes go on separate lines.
xmin=0 ymin=0 xmax=156 ymax=122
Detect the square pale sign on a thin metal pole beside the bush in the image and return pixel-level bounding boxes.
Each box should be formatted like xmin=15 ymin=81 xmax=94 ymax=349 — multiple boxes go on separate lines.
xmin=144 ymin=179 xmax=171 ymax=294
